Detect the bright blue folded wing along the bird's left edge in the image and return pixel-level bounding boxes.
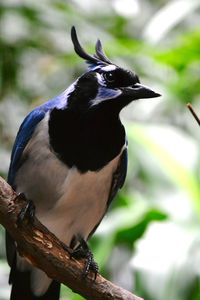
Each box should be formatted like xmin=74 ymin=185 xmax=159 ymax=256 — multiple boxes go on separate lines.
xmin=8 ymin=94 xmax=66 ymax=186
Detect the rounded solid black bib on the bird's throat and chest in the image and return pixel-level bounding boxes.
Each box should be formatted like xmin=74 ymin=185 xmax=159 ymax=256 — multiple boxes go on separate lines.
xmin=49 ymin=105 xmax=125 ymax=172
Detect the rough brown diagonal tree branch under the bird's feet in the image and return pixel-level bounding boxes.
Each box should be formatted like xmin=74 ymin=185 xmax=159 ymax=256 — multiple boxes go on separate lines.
xmin=0 ymin=177 xmax=142 ymax=300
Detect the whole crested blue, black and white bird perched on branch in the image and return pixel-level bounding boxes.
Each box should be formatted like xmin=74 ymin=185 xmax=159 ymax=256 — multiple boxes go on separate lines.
xmin=6 ymin=27 xmax=160 ymax=300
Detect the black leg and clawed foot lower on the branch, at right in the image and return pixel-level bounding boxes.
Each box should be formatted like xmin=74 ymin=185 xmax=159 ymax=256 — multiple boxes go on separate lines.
xmin=71 ymin=236 xmax=99 ymax=280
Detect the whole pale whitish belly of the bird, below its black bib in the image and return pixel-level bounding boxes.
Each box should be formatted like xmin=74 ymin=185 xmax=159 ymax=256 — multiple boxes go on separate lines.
xmin=16 ymin=147 xmax=120 ymax=245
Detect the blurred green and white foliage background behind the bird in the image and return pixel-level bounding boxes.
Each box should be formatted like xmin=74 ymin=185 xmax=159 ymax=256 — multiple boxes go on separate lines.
xmin=0 ymin=0 xmax=200 ymax=300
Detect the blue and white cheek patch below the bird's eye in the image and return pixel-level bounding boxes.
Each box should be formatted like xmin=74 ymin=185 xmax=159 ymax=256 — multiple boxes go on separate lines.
xmin=90 ymin=87 xmax=122 ymax=107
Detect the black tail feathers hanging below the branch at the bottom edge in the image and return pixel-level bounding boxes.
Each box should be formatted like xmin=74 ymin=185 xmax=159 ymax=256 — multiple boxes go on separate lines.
xmin=10 ymin=269 xmax=60 ymax=300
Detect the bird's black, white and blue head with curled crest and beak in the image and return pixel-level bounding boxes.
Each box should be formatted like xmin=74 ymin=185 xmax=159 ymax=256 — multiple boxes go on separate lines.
xmin=69 ymin=27 xmax=160 ymax=111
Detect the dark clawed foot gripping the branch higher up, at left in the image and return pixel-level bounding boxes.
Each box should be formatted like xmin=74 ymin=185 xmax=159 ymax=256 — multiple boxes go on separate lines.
xmin=17 ymin=194 xmax=35 ymax=226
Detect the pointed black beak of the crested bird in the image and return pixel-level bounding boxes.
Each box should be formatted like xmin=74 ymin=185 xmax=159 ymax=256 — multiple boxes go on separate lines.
xmin=121 ymin=83 xmax=161 ymax=100
